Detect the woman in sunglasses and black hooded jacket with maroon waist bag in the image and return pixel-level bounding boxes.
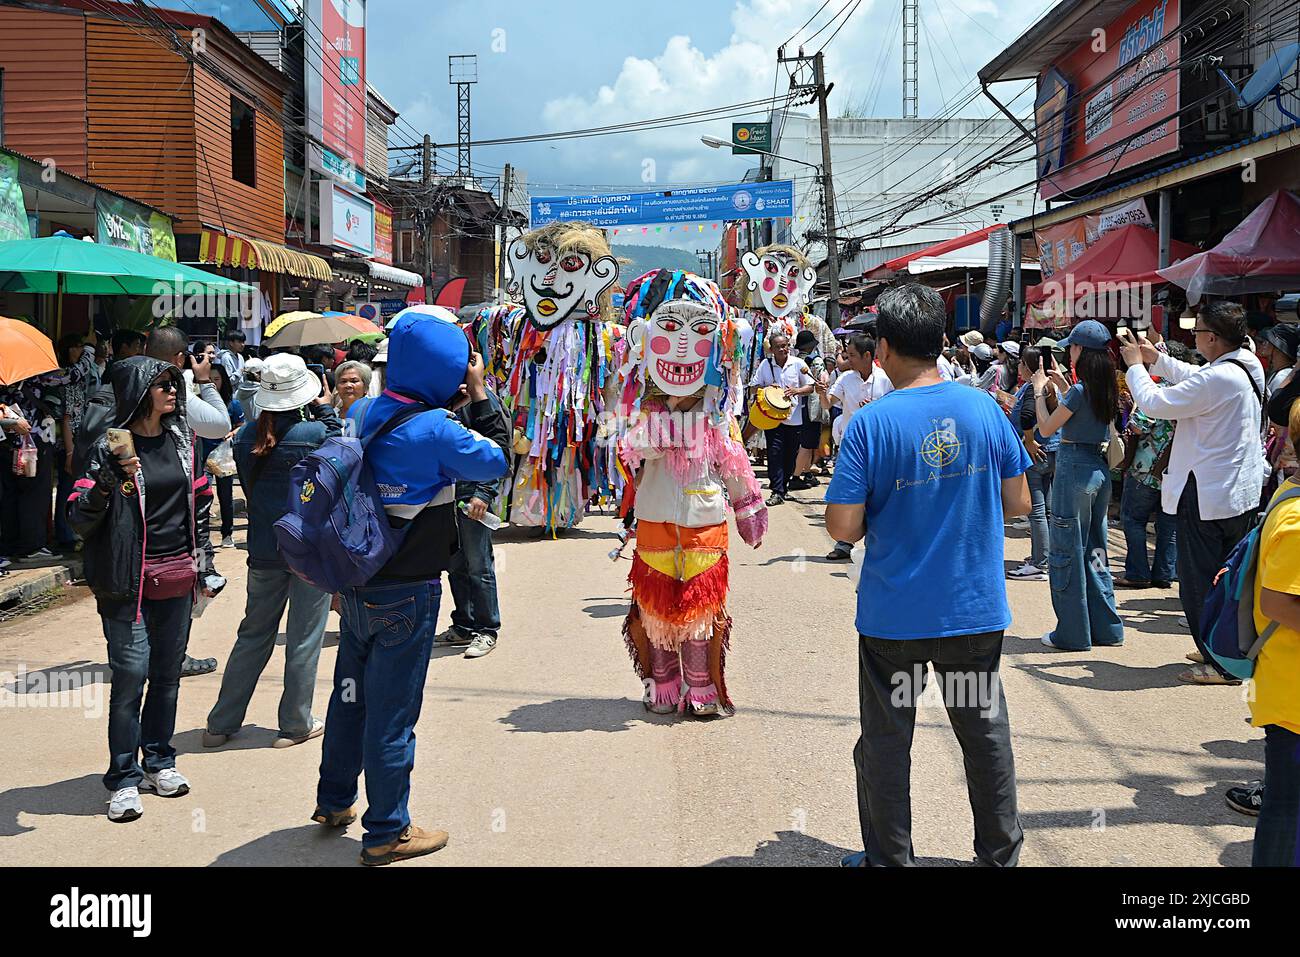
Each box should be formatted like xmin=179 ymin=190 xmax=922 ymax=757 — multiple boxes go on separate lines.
xmin=69 ymin=356 xmax=225 ymax=822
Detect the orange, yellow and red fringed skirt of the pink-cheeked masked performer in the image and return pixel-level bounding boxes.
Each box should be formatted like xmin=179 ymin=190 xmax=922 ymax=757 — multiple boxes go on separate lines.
xmin=623 ymin=521 xmax=733 ymax=711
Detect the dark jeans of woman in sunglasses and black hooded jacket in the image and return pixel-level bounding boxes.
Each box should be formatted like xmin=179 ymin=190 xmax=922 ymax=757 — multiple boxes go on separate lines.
xmin=101 ymin=594 xmax=194 ymax=791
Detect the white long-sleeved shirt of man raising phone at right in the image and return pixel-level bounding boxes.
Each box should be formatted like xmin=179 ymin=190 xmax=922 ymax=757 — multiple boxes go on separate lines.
xmin=1126 ymin=348 xmax=1265 ymax=521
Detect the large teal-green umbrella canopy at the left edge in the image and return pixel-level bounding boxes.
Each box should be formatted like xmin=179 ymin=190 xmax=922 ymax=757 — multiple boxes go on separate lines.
xmin=0 ymin=235 xmax=256 ymax=295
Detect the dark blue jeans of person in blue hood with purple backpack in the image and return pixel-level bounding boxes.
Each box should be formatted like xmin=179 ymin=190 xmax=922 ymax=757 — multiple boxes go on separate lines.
xmin=316 ymin=581 xmax=442 ymax=848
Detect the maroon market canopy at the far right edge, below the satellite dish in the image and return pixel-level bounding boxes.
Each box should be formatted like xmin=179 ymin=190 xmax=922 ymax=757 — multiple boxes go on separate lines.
xmin=1160 ymin=190 xmax=1300 ymax=303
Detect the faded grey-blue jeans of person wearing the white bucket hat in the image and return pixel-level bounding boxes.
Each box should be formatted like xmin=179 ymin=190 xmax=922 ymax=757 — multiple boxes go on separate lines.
xmin=208 ymin=568 xmax=330 ymax=737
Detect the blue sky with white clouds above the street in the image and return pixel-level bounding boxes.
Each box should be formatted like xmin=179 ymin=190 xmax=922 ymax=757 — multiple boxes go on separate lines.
xmin=183 ymin=0 xmax=1052 ymax=244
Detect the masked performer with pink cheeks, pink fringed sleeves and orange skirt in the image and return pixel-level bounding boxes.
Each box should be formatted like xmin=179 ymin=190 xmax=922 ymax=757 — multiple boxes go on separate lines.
xmin=620 ymin=269 xmax=767 ymax=716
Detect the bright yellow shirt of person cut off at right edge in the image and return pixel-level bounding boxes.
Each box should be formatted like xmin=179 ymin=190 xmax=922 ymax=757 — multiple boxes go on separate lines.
xmin=1251 ymin=479 xmax=1300 ymax=735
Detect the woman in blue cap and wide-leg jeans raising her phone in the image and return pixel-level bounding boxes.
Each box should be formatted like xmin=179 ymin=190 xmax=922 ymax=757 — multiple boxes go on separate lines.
xmin=1032 ymin=319 xmax=1125 ymax=651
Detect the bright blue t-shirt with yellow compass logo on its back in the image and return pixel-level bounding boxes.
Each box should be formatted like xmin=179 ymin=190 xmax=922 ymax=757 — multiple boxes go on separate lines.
xmin=826 ymin=382 xmax=1032 ymax=638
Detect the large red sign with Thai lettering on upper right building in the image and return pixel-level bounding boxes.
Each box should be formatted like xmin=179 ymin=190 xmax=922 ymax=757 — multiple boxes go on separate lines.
xmin=1039 ymin=0 xmax=1182 ymax=199
